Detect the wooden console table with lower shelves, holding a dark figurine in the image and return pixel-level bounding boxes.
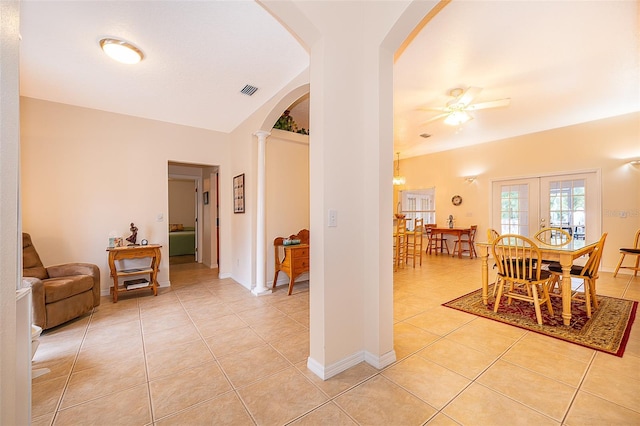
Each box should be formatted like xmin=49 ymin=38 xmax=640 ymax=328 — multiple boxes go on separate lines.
xmin=107 ymin=244 xmax=162 ymax=303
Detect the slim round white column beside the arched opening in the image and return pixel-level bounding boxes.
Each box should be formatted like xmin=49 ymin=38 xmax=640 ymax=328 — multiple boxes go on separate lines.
xmin=251 ymin=130 xmax=271 ymax=296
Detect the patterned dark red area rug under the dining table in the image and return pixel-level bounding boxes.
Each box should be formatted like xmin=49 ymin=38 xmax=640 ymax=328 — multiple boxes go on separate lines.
xmin=442 ymin=286 xmax=638 ymax=357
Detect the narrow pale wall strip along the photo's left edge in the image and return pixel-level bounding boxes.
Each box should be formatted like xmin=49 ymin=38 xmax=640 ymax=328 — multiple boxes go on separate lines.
xmin=0 ymin=1 xmax=23 ymax=425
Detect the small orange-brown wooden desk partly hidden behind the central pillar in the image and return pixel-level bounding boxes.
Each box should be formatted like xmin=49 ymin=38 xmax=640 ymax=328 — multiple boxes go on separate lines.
xmin=272 ymin=229 xmax=309 ymax=296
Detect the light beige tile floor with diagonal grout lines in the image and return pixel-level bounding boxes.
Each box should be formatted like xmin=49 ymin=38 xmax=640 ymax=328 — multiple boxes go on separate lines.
xmin=32 ymin=255 xmax=640 ymax=426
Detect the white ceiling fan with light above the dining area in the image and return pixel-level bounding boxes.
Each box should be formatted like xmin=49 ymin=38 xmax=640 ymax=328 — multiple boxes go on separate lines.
xmin=421 ymin=87 xmax=511 ymax=126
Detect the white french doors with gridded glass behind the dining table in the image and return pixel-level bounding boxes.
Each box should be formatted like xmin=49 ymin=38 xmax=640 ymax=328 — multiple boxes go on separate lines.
xmin=491 ymin=172 xmax=602 ymax=241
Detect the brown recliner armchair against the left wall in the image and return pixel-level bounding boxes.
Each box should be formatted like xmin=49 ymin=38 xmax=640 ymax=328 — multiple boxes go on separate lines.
xmin=22 ymin=233 xmax=100 ymax=330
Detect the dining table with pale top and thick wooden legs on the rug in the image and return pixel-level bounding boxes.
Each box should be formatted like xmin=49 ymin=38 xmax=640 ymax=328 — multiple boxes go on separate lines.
xmin=476 ymin=239 xmax=598 ymax=325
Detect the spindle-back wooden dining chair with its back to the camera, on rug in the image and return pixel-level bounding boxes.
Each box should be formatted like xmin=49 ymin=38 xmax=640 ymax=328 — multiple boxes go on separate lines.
xmin=491 ymin=234 xmax=553 ymax=325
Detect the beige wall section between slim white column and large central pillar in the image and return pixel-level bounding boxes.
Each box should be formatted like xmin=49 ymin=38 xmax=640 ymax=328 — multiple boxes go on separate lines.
xmin=266 ymin=129 xmax=309 ymax=287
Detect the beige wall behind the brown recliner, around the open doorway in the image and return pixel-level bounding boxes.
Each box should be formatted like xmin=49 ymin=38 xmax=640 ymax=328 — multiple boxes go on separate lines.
xmin=20 ymin=98 xmax=232 ymax=294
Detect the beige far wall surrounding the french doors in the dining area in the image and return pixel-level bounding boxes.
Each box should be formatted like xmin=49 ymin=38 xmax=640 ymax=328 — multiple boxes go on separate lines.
xmin=400 ymin=113 xmax=640 ymax=270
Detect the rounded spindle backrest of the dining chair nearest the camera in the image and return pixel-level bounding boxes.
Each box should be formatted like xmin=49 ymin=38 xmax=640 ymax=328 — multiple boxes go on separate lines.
xmin=491 ymin=234 xmax=542 ymax=282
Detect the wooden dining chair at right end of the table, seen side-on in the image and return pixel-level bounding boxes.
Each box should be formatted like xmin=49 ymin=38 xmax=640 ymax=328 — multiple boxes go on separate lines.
xmin=549 ymin=232 xmax=607 ymax=318
